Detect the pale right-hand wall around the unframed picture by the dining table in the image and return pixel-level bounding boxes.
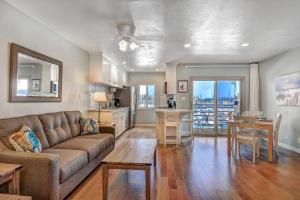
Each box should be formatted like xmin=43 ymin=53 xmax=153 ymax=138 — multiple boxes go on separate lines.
xmin=259 ymin=48 xmax=300 ymax=152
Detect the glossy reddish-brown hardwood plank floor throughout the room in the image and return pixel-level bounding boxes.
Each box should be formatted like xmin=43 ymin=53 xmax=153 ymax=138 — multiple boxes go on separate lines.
xmin=68 ymin=128 xmax=300 ymax=200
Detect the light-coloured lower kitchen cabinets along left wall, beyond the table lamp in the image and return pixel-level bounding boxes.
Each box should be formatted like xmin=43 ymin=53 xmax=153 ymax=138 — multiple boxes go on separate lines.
xmin=89 ymin=107 xmax=129 ymax=138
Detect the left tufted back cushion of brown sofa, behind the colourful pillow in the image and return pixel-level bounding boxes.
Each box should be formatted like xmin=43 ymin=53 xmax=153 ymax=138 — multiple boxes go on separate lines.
xmin=0 ymin=115 xmax=49 ymax=150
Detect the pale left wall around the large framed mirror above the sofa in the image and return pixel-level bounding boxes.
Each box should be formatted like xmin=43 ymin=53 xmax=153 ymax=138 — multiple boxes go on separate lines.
xmin=0 ymin=1 xmax=89 ymax=118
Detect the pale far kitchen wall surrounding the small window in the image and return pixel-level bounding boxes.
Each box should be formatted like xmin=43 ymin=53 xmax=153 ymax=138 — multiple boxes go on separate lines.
xmin=128 ymin=72 xmax=165 ymax=124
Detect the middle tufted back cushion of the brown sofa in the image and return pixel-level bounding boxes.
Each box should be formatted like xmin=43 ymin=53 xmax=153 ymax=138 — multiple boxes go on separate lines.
xmin=39 ymin=112 xmax=72 ymax=146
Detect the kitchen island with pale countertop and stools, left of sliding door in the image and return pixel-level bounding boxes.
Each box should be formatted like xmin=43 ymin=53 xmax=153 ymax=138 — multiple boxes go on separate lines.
xmin=155 ymin=109 xmax=194 ymax=145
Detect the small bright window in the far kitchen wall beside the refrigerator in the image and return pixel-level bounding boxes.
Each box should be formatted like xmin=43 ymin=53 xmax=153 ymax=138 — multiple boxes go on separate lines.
xmin=138 ymin=85 xmax=155 ymax=108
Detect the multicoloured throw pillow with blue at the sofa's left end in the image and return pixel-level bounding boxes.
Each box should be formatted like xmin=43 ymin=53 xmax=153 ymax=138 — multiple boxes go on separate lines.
xmin=9 ymin=125 xmax=42 ymax=153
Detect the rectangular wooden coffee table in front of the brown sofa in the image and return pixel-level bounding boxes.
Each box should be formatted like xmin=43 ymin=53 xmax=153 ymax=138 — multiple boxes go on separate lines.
xmin=101 ymin=139 xmax=157 ymax=200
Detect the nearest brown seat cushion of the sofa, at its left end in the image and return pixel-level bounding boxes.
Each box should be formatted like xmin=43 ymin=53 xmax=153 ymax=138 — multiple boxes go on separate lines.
xmin=42 ymin=148 xmax=88 ymax=183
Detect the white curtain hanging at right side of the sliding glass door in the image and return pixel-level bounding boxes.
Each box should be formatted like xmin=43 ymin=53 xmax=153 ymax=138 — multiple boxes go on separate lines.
xmin=249 ymin=63 xmax=260 ymax=111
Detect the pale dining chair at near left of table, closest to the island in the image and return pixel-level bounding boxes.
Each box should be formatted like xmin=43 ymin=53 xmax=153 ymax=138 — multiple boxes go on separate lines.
xmin=233 ymin=116 xmax=260 ymax=163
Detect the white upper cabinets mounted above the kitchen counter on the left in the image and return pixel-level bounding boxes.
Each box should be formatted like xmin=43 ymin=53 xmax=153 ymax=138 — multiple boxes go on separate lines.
xmin=89 ymin=53 xmax=127 ymax=87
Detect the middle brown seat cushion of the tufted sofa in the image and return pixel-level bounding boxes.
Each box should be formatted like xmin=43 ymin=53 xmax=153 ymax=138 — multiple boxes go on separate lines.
xmin=52 ymin=137 xmax=105 ymax=162
